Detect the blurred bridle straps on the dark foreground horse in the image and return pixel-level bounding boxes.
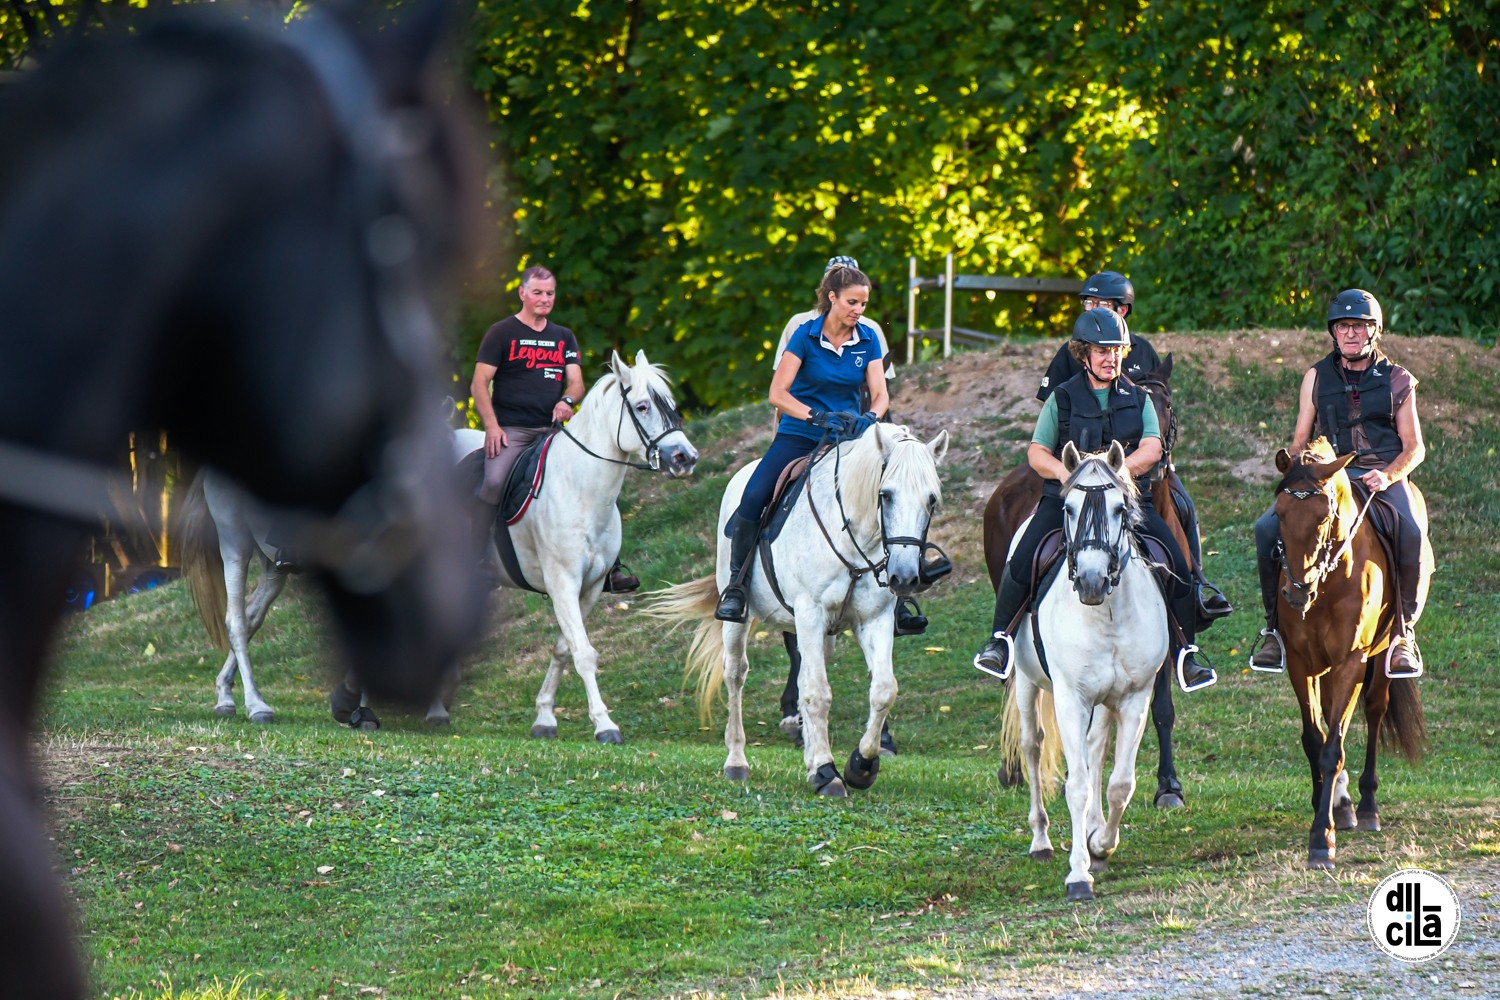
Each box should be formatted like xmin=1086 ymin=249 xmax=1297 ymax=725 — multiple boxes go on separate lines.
xmin=0 ymin=10 xmax=437 ymax=594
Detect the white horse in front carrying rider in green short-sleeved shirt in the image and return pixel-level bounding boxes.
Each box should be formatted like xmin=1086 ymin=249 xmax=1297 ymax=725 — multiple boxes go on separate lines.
xmin=1002 ymin=442 xmax=1169 ymax=903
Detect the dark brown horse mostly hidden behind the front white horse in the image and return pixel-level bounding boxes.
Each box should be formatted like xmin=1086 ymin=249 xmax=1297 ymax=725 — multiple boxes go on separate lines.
xmin=984 ymin=354 xmax=1191 ymax=808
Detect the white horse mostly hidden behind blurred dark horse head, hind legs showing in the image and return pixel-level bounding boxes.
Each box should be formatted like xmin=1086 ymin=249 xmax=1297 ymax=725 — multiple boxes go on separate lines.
xmin=177 ymin=469 xmax=458 ymax=729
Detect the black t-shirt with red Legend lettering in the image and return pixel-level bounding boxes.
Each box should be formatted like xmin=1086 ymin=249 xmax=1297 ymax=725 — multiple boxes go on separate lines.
xmin=477 ymin=316 xmax=579 ymax=427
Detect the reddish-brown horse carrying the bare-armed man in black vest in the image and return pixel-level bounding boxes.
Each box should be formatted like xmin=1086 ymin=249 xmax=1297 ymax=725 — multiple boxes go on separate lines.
xmin=1275 ymin=438 xmax=1427 ymax=868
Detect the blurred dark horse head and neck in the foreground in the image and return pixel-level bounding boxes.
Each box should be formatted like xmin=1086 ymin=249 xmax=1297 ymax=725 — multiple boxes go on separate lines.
xmin=0 ymin=3 xmax=482 ymax=997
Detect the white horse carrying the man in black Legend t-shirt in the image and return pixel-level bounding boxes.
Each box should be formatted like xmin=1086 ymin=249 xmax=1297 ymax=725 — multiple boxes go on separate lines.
xmin=455 ymin=351 xmax=698 ymax=744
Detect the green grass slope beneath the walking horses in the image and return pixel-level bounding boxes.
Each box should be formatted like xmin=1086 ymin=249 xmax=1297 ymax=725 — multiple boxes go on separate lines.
xmin=41 ymin=332 xmax=1500 ymax=1000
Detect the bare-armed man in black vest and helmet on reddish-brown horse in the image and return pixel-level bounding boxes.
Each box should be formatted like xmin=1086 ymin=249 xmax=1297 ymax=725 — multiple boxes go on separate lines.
xmin=1250 ymin=288 xmax=1431 ymax=678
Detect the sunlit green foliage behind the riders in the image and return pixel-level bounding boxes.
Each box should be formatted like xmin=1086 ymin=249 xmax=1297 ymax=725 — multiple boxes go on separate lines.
xmin=461 ymin=0 xmax=1500 ymax=406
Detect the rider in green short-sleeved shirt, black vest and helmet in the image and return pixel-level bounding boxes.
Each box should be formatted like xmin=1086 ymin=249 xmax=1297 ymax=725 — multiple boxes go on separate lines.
xmin=974 ymin=307 xmax=1218 ymax=691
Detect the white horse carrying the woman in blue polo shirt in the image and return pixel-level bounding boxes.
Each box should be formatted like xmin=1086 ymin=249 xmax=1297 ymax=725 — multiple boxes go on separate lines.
xmin=648 ymin=424 xmax=948 ymax=796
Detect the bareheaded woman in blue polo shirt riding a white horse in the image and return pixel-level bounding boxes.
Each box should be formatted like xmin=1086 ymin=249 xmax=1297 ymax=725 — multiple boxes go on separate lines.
xmin=714 ymin=264 xmax=890 ymax=622
